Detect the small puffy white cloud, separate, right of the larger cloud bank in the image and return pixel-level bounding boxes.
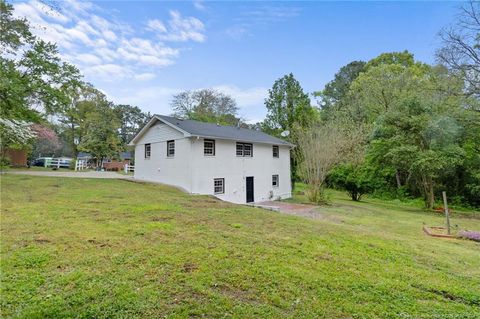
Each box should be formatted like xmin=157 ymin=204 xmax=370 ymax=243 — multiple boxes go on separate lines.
xmin=147 ymin=10 xmax=206 ymax=42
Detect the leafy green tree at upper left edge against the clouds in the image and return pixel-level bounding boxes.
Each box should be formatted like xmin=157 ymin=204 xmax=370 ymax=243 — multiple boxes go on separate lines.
xmin=0 ymin=0 xmax=80 ymax=122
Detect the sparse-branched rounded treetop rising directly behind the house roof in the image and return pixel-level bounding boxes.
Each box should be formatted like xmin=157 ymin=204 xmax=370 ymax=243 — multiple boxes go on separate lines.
xmin=171 ymin=89 xmax=241 ymax=126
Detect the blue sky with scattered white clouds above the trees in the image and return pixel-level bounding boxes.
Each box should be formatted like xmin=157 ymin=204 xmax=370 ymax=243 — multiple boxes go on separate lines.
xmin=12 ymin=0 xmax=461 ymax=123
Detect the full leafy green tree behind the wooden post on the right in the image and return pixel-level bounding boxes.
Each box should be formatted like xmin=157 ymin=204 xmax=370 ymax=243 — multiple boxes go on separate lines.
xmin=370 ymin=94 xmax=464 ymax=208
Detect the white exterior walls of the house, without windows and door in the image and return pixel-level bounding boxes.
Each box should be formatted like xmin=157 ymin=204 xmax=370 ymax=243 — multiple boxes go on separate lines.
xmin=131 ymin=122 xmax=291 ymax=203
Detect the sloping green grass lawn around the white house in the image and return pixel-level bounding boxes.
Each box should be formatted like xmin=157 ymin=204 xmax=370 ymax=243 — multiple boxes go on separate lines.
xmin=0 ymin=175 xmax=480 ymax=318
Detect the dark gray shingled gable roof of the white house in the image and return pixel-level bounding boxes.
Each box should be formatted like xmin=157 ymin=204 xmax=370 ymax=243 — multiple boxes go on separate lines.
xmin=131 ymin=115 xmax=293 ymax=146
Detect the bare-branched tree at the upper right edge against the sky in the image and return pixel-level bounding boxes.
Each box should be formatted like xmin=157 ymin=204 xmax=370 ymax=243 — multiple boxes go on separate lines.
xmin=436 ymin=1 xmax=480 ymax=100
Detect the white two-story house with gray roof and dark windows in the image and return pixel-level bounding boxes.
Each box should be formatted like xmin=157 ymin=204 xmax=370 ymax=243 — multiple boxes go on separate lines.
xmin=130 ymin=115 xmax=293 ymax=203
